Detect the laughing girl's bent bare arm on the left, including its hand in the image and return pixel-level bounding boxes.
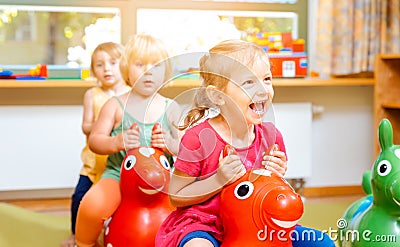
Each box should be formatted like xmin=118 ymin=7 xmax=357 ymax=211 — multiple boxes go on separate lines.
xmin=169 ymin=152 xmax=246 ymax=207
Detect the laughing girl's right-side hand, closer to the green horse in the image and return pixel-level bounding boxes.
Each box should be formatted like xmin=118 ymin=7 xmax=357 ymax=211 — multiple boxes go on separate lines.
xmin=262 ymin=144 xmax=287 ymax=177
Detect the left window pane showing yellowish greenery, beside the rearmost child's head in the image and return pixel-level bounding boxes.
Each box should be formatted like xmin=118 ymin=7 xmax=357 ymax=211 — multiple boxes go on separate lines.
xmin=0 ymin=5 xmax=121 ymax=67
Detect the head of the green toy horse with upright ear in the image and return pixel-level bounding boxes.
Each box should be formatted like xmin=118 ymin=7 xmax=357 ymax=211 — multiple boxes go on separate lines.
xmin=371 ymin=119 xmax=400 ymax=215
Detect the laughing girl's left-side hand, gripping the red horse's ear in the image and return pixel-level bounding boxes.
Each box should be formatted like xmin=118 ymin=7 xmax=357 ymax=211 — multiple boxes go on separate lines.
xmin=217 ymin=151 xmax=246 ymax=186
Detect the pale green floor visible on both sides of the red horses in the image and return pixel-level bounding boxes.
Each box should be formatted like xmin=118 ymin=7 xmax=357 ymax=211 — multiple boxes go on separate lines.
xmin=0 ymin=200 xmax=351 ymax=247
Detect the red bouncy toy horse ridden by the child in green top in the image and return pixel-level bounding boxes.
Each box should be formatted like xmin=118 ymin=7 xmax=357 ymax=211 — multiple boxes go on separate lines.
xmin=104 ymin=125 xmax=174 ymax=247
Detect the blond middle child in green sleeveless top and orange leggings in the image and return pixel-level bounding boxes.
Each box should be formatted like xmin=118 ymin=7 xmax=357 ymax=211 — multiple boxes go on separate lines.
xmin=76 ymin=34 xmax=179 ymax=247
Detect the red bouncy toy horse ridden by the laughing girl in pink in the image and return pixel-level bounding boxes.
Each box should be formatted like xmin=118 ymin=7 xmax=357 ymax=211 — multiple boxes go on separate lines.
xmin=220 ymin=147 xmax=304 ymax=247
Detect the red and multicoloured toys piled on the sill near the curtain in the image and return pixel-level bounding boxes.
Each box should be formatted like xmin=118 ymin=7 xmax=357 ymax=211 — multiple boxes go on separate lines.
xmin=247 ymin=32 xmax=308 ymax=77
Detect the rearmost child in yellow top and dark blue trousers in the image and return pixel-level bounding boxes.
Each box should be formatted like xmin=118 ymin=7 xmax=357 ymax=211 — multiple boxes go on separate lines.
xmin=61 ymin=42 xmax=130 ymax=247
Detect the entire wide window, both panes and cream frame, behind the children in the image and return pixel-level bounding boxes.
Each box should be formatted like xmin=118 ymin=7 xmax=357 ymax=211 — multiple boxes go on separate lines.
xmin=0 ymin=0 xmax=308 ymax=77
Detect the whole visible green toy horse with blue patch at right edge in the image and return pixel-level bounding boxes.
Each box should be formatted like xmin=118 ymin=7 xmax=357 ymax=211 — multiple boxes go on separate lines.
xmin=338 ymin=119 xmax=400 ymax=247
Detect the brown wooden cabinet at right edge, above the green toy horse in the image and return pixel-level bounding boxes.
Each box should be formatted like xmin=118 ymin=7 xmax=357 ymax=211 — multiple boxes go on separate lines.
xmin=374 ymin=54 xmax=400 ymax=155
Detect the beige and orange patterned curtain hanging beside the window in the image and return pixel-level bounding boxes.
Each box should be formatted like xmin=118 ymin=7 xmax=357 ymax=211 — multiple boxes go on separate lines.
xmin=316 ymin=0 xmax=400 ymax=76
